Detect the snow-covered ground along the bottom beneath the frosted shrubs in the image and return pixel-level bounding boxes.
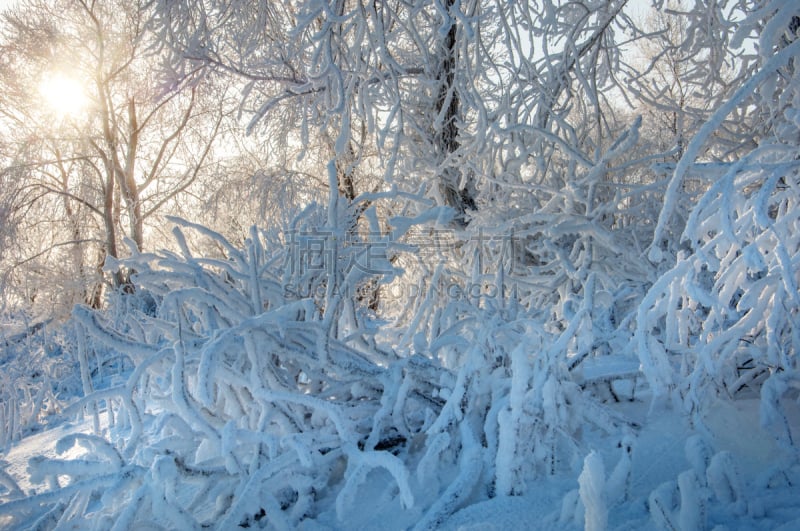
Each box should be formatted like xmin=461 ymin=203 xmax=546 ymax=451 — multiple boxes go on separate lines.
xmin=0 ymin=378 xmax=800 ymax=531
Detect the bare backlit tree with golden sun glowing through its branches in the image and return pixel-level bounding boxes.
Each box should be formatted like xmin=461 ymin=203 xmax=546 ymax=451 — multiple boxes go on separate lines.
xmin=2 ymin=0 xmax=227 ymax=312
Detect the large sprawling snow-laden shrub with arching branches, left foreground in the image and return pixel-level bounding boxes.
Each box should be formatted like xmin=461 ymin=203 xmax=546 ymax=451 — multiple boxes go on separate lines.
xmin=3 ymin=204 xmax=456 ymax=528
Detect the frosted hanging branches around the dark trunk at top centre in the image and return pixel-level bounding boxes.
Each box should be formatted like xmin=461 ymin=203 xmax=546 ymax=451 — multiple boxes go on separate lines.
xmin=153 ymin=0 xmax=628 ymax=222
